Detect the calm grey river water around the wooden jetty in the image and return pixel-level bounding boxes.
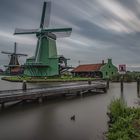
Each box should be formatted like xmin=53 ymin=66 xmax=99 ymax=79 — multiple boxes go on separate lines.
xmin=0 ymin=78 xmax=138 ymax=140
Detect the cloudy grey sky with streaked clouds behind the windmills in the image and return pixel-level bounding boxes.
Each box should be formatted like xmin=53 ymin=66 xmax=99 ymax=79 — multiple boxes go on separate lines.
xmin=0 ymin=0 xmax=140 ymax=70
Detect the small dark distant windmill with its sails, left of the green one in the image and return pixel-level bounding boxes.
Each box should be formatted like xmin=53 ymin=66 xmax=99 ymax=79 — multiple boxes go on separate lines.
xmin=1 ymin=42 xmax=27 ymax=73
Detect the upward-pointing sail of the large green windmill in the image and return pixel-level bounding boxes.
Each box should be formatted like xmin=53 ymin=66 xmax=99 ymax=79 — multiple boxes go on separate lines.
xmin=40 ymin=1 xmax=51 ymax=29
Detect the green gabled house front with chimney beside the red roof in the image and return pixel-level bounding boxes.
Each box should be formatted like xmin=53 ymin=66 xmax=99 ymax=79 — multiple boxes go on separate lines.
xmin=100 ymin=59 xmax=118 ymax=79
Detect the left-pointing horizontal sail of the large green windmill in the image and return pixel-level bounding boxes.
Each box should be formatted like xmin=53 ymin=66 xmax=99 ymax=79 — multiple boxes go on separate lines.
xmin=14 ymin=28 xmax=38 ymax=35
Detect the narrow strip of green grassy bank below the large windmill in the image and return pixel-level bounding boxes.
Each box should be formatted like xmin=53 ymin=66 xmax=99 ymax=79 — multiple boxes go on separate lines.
xmin=1 ymin=76 xmax=96 ymax=83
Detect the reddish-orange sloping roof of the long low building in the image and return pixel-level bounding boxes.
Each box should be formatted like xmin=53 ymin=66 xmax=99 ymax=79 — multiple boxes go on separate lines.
xmin=72 ymin=64 xmax=104 ymax=72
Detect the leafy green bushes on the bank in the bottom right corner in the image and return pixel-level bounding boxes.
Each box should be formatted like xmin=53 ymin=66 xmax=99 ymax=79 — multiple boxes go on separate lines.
xmin=106 ymin=99 xmax=140 ymax=140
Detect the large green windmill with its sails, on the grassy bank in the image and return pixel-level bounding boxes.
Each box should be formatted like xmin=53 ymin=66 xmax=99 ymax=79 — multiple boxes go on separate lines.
xmin=14 ymin=1 xmax=72 ymax=77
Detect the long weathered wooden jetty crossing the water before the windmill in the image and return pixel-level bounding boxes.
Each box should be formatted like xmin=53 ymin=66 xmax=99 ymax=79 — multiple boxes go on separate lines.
xmin=0 ymin=82 xmax=107 ymax=108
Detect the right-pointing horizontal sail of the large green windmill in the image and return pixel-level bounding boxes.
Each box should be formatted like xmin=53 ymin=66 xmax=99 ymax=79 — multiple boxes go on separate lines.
xmin=43 ymin=28 xmax=72 ymax=38
